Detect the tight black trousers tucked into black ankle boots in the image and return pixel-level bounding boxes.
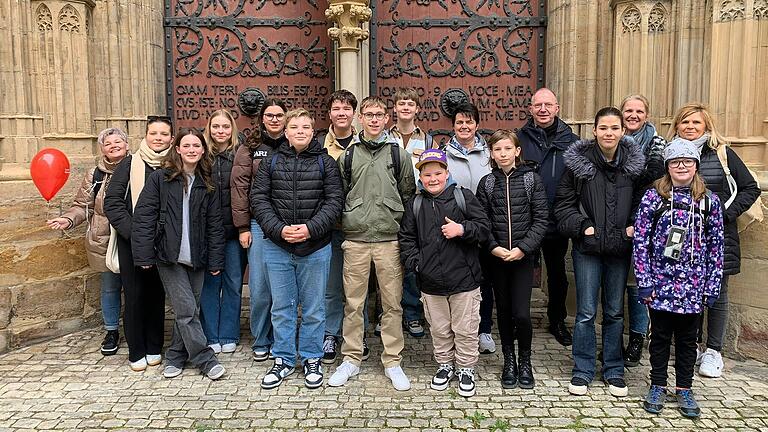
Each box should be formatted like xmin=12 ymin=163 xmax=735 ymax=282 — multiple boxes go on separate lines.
xmin=492 ymin=257 xmax=533 ymax=352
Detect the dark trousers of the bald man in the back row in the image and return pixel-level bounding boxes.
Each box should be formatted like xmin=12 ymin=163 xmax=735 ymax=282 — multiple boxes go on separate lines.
xmin=541 ymin=236 xmax=568 ymax=325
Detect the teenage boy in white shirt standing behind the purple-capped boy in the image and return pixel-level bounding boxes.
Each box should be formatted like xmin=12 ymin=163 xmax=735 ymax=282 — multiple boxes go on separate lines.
xmin=389 ymin=87 xmax=433 ymax=338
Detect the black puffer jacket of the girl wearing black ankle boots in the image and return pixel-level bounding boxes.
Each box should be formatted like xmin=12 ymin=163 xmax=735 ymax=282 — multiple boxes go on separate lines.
xmin=477 ymin=163 xmax=549 ymax=255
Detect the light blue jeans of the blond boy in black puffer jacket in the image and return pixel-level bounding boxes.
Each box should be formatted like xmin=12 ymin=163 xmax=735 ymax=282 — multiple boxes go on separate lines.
xmin=264 ymin=240 xmax=331 ymax=366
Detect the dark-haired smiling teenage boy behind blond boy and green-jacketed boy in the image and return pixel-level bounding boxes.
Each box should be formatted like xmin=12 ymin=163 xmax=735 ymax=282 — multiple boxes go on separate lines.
xmin=317 ymin=89 xmax=369 ymax=364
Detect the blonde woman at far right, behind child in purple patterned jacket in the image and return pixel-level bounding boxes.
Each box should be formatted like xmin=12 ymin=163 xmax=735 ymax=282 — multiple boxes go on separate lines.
xmin=670 ymin=102 xmax=760 ymax=378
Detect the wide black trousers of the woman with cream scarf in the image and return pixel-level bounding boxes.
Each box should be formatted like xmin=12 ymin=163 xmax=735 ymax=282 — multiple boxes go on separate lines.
xmin=117 ymin=236 xmax=165 ymax=362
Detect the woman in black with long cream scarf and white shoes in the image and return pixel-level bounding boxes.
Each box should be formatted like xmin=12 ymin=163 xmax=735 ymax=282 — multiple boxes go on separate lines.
xmin=104 ymin=116 xmax=173 ymax=372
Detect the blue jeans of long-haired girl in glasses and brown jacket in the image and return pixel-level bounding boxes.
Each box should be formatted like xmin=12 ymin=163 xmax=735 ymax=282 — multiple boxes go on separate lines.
xmin=248 ymin=219 xmax=273 ymax=350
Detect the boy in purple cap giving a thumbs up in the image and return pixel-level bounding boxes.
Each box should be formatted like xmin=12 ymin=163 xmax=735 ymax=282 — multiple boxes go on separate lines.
xmin=398 ymin=149 xmax=489 ymax=397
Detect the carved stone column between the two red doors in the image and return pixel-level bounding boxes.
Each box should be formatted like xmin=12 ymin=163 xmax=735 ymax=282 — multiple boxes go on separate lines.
xmin=325 ymin=0 xmax=371 ymax=98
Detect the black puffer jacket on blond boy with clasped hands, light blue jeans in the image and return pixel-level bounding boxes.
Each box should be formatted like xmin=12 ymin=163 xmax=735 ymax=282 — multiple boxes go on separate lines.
xmin=251 ymin=140 xmax=344 ymax=256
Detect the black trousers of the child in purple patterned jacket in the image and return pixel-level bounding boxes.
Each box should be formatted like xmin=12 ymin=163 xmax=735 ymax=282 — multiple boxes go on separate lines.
xmin=648 ymin=309 xmax=701 ymax=388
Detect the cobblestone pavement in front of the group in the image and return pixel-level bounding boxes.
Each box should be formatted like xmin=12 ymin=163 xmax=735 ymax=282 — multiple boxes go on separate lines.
xmin=0 ymin=300 xmax=768 ymax=432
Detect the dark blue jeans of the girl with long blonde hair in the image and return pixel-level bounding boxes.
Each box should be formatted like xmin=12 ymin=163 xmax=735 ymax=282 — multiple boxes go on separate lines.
xmin=200 ymin=239 xmax=247 ymax=345
